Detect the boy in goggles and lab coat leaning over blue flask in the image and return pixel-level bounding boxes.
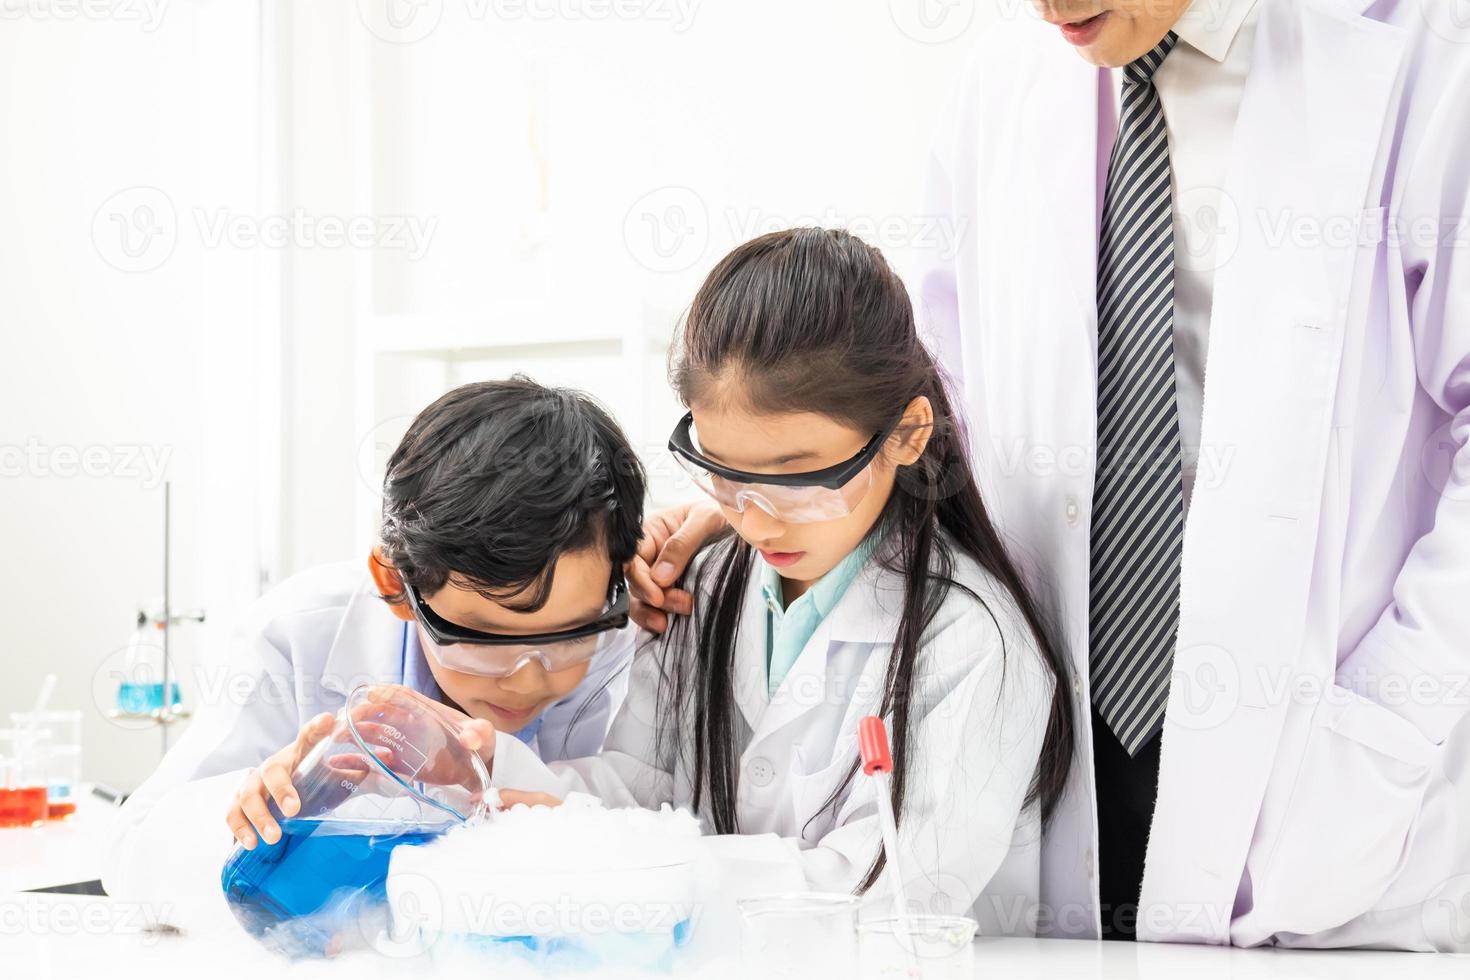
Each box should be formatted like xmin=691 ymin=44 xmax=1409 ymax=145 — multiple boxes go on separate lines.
xmin=103 ymin=378 xmax=644 ymax=896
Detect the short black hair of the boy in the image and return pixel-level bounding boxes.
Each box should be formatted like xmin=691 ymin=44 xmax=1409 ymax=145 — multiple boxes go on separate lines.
xmin=381 ymin=375 xmax=645 ymax=611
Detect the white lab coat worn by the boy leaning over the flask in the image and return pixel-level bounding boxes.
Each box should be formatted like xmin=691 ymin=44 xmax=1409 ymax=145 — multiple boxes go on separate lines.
xmin=103 ymin=561 xmax=634 ymax=922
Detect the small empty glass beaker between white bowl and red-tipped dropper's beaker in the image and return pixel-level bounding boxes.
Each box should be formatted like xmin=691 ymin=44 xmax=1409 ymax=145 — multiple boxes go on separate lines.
xmin=735 ymin=892 xmax=858 ymax=980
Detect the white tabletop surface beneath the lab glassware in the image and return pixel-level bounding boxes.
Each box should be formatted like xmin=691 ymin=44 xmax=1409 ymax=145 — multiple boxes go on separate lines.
xmin=0 ymin=795 xmax=1470 ymax=980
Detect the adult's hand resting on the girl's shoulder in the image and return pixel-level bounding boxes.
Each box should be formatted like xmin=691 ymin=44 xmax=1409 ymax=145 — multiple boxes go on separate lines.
xmin=625 ymin=500 xmax=729 ymax=633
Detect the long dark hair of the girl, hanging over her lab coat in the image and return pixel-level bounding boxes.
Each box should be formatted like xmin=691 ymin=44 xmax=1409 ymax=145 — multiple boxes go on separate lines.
xmin=659 ymin=228 xmax=1075 ymax=890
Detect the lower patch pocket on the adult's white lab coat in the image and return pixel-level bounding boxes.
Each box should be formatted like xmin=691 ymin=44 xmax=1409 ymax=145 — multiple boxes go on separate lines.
xmin=1251 ymin=686 xmax=1439 ymax=933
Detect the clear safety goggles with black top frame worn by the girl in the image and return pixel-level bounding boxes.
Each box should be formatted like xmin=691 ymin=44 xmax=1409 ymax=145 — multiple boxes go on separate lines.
xmin=669 ymin=411 xmax=898 ymax=525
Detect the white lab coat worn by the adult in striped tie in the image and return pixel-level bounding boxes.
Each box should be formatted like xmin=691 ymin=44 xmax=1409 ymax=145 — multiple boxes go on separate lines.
xmin=920 ymin=0 xmax=1470 ymax=949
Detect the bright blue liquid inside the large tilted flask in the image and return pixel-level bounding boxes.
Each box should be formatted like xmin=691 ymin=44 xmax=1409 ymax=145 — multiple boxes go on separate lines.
xmin=221 ymin=815 xmax=447 ymax=955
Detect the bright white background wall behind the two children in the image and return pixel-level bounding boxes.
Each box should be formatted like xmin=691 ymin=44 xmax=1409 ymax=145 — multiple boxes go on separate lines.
xmin=0 ymin=0 xmax=1026 ymax=788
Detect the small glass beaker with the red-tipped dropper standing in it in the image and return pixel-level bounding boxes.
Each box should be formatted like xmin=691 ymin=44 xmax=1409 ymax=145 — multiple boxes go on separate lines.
xmin=857 ymin=915 xmax=979 ymax=980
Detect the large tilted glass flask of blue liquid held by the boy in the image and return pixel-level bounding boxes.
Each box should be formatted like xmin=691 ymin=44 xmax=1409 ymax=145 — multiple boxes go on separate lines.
xmin=221 ymin=685 xmax=490 ymax=955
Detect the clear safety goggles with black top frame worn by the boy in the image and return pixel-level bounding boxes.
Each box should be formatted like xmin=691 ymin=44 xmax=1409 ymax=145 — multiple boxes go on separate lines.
xmin=403 ymin=577 xmax=628 ymax=677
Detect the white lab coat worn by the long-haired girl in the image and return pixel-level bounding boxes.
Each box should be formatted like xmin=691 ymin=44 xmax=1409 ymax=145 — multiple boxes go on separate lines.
xmin=491 ymin=545 xmax=1053 ymax=934
